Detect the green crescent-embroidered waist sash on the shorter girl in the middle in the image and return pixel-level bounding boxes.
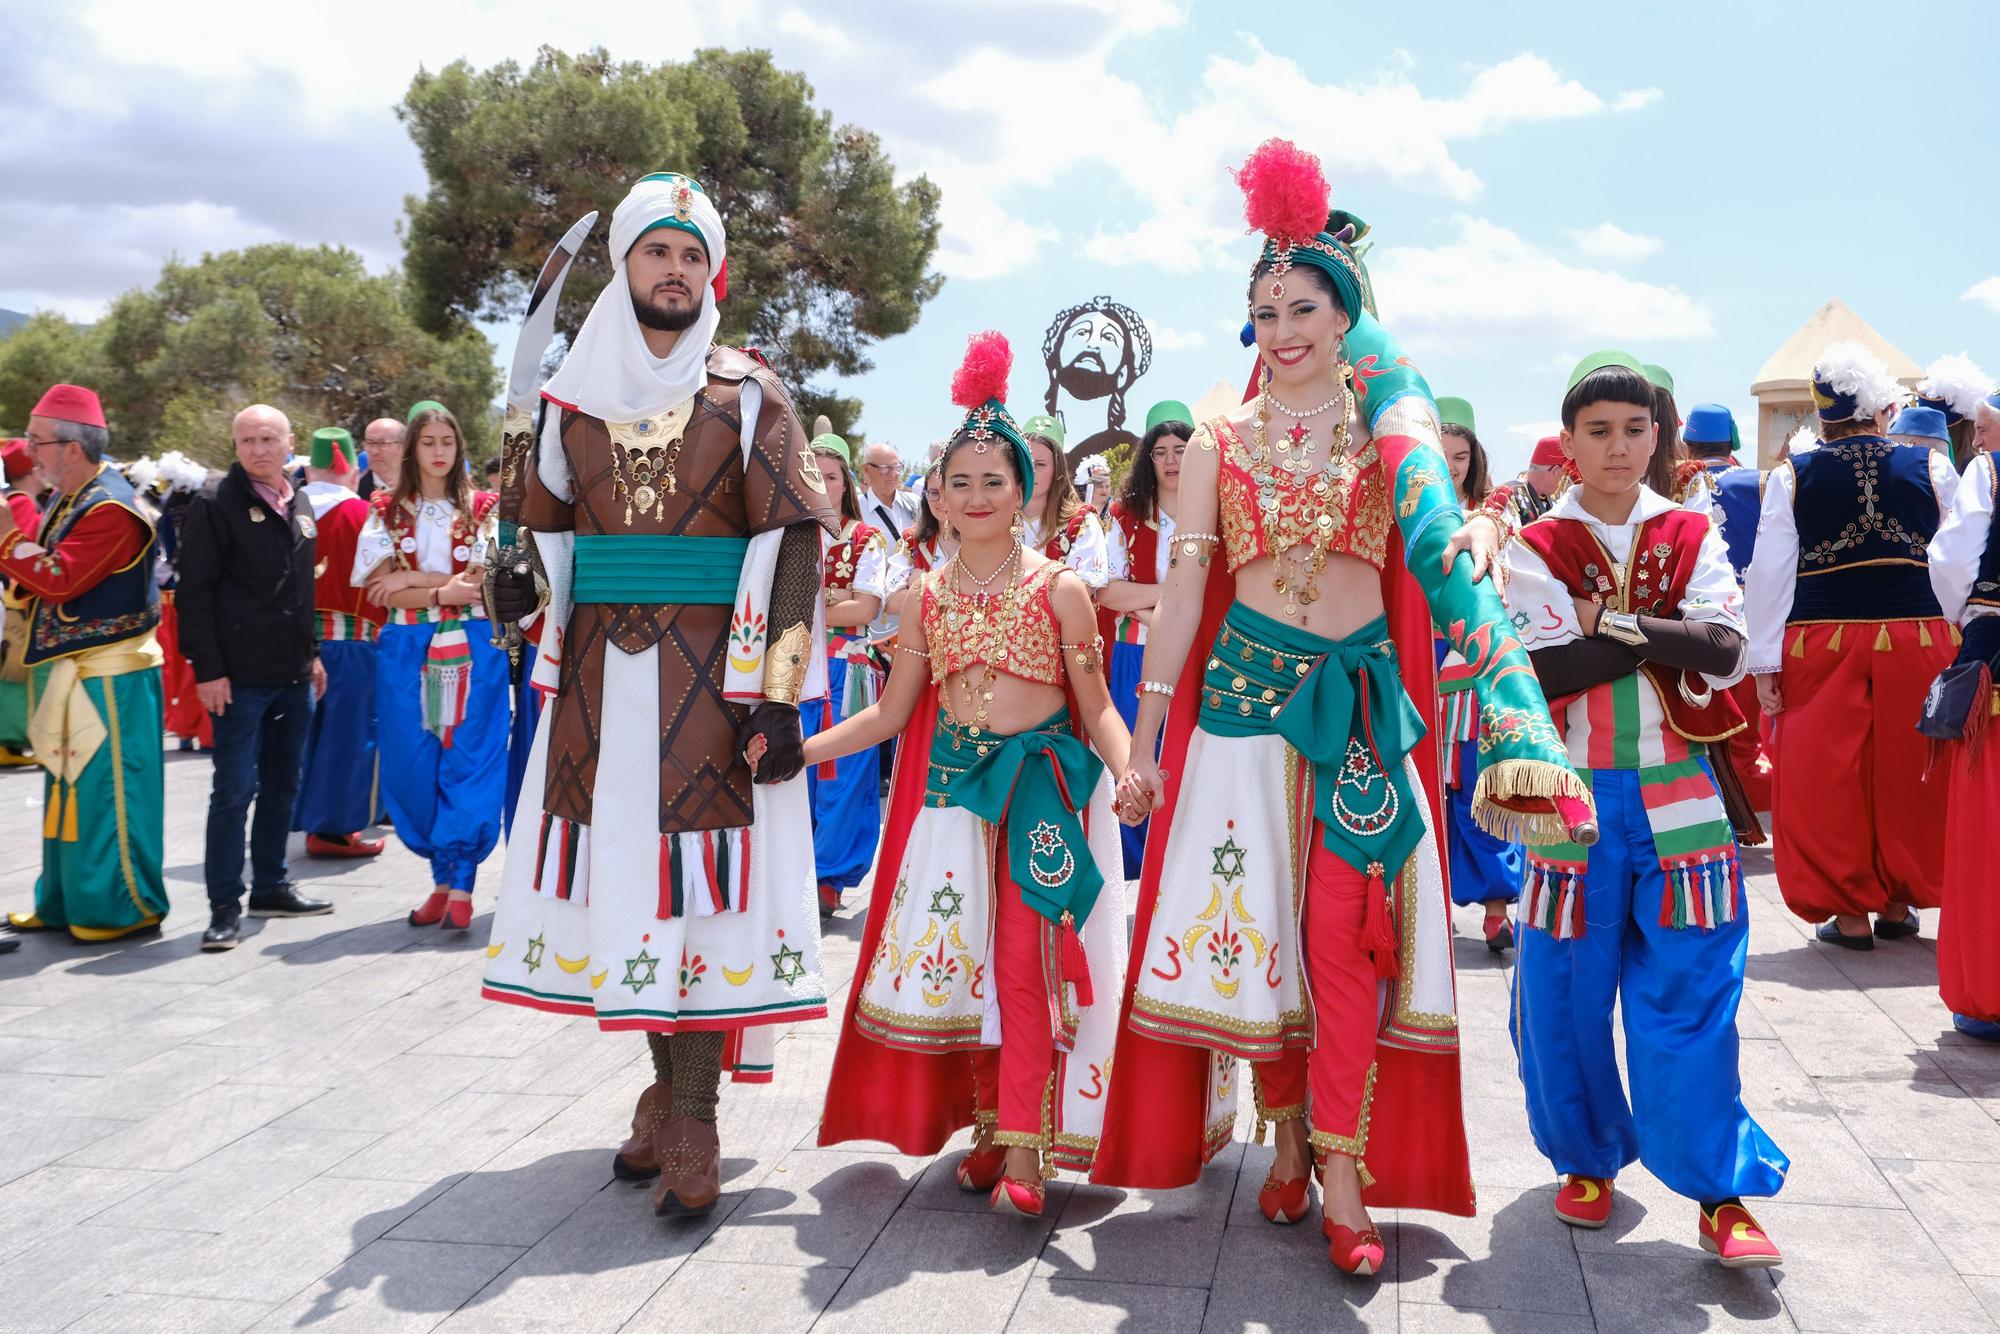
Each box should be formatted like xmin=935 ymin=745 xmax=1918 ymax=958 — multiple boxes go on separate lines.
xmin=924 ymin=706 xmax=1104 ymax=930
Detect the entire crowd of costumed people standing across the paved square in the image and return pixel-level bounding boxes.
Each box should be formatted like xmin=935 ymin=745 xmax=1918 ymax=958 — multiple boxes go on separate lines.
xmin=0 ymin=140 xmax=2000 ymax=1274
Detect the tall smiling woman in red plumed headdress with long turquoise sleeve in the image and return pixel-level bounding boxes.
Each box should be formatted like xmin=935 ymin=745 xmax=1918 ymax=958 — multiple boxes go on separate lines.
xmin=1092 ymin=140 xmax=1588 ymax=1274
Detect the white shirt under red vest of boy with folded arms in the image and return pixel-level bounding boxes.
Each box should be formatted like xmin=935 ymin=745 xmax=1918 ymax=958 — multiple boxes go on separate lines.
xmin=1506 ymin=484 xmax=1744 ymax=764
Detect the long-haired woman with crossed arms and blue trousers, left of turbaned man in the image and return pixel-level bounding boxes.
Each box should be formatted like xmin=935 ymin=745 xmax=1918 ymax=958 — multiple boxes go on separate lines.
xmin=352 ymin=400 xmax=510 ymax=930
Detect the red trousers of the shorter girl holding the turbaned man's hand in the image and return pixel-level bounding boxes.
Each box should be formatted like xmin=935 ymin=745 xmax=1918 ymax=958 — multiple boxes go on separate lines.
xmin=972 ymin=844 xmax=1056 ymax=1150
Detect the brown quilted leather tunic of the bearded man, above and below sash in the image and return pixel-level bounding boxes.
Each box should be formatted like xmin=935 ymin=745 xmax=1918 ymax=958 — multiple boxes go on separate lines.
xmin=522 ymin=348 xmax=834 ymax=834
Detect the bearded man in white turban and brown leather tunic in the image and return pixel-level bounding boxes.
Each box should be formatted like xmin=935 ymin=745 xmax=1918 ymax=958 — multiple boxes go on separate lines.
xmin=484 ymin=172 xmax=832 ymax=1214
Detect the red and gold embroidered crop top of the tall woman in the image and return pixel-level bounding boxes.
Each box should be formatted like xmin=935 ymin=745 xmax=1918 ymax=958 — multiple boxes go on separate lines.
xmin=1194 ymin=418 xmax=1392 ymax=574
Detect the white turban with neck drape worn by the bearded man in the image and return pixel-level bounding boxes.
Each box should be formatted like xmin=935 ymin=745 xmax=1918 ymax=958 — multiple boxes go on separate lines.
xmin=542 ymin=172 xmax=728 ymax=422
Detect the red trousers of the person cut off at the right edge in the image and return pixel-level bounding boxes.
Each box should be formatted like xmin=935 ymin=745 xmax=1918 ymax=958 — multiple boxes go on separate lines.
xmin=1930 ymin=700 xmax=2000 ymax=1022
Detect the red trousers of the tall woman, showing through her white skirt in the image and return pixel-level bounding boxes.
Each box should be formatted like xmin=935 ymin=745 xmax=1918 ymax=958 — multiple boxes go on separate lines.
xmin=1252 ymin=824 xmax=1382 ymax=1160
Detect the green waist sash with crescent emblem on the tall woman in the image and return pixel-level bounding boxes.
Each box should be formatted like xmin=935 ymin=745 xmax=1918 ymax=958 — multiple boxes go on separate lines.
xmin=1200 ymin=602 xmax=1428 ymax=878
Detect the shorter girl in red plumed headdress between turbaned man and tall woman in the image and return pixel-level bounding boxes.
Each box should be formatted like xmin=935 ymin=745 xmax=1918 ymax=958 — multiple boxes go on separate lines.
xmin=806 ymin=334 xmax=1130 ymax=1214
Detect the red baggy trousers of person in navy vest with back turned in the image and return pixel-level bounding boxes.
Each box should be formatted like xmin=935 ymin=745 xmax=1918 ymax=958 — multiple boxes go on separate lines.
xmin=1772 ymin=620 xmax=1956 ymax=922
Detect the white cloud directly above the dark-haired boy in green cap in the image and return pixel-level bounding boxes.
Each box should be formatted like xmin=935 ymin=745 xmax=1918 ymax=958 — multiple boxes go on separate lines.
xmin=1374 ymin=216 xmax=1716 ymax=350
